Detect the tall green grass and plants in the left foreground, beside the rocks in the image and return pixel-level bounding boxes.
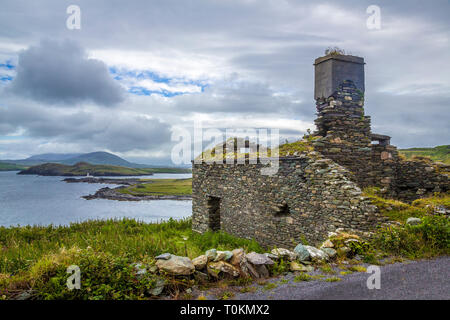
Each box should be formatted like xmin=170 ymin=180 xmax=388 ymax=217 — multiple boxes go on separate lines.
xmin=0 ymin=219 xmax=263 ymax=299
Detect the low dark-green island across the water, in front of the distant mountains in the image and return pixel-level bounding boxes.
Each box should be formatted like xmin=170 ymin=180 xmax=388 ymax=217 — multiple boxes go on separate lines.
xmin=17 ymin=162 xmax=191 ymax=177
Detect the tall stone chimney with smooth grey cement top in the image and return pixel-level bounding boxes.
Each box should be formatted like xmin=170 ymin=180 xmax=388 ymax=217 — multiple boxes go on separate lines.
xmin=314 ymin=55 xmax=371 ymax=185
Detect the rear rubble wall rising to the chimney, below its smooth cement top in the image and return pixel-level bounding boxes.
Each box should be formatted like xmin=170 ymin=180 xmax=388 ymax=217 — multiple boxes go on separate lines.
xmin=314 ymin=80 xmax=449 ymax=201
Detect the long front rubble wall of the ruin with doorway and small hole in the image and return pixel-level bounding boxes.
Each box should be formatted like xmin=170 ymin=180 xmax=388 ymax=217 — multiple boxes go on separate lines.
xmin=192 ymin=153 xmax=385 ymax=248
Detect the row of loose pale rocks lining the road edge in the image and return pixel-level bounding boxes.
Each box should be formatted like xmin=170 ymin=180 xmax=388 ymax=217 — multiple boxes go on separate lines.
xmin=149 ymin=232 xmax=361 ymax=288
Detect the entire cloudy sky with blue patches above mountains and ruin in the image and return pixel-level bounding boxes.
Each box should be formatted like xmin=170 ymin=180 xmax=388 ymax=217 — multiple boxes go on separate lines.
xmin=0 ymin=0 xmax=450 ymax=163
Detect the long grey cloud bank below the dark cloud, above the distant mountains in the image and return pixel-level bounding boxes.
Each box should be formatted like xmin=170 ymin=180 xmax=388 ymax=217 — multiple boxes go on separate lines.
xmin=0 ymin=100 xmax=170 ymax=152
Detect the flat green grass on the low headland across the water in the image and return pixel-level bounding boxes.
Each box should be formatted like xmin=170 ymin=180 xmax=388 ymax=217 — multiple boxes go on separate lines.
xmin=119 ymin=179 xmax=192 ymax=196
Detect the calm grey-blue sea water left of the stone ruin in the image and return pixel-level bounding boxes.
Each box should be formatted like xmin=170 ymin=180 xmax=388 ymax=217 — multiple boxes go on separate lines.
xmin=0 ymin=171 xmax=192 ymax=226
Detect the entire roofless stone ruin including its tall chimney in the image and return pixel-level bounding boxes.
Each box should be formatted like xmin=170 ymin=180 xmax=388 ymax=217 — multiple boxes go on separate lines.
xmin=192 ymin=55 xmax=450 ymax=248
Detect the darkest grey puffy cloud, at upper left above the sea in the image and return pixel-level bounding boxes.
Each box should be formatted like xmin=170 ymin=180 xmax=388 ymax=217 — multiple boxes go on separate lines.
xmin=11 ymin=40 xmax=124 ymax=106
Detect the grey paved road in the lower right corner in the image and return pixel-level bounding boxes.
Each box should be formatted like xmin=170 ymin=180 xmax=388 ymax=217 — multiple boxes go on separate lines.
xmin=234 ymin=257 xmax=450 ymax=300
